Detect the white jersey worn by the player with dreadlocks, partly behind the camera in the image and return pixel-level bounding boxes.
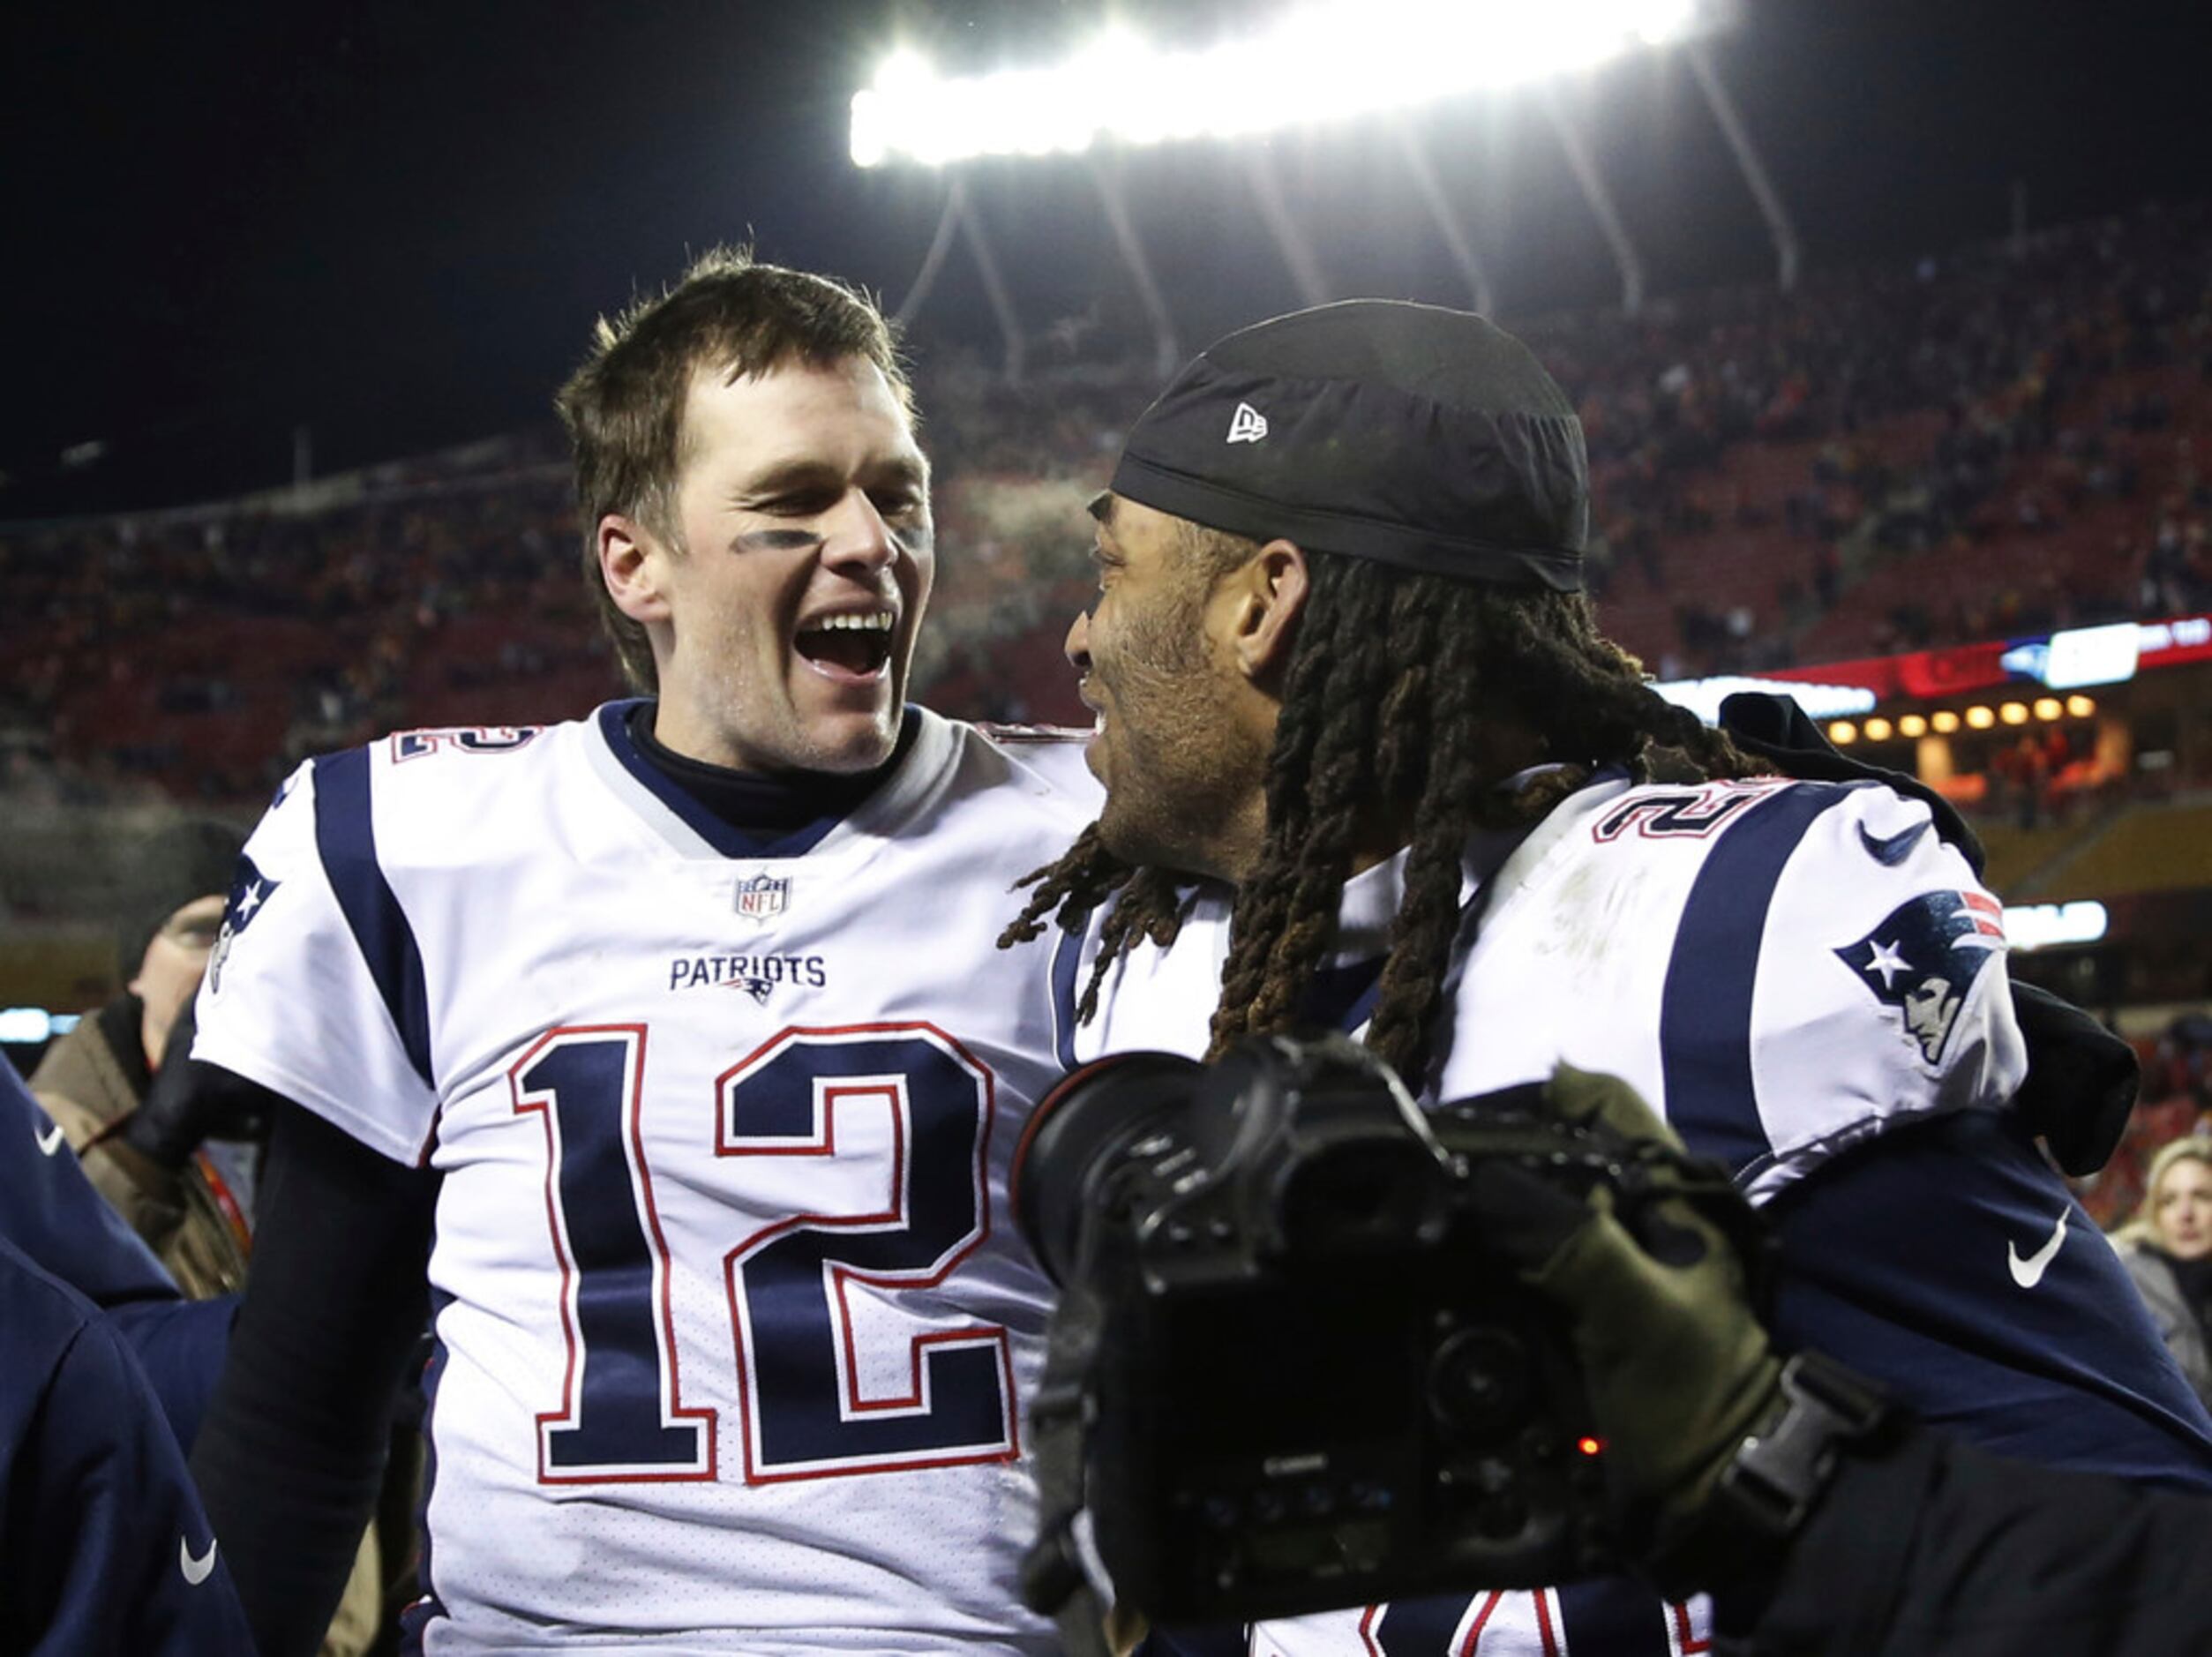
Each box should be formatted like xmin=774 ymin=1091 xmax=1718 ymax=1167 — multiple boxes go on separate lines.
xmin=1055 ymin=776 xmax=2026 ymax=1657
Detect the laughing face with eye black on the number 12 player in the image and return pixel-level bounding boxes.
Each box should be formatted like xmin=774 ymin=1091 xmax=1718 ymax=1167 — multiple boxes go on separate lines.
xmin=646 ymin=358 xmax=935 ymax=775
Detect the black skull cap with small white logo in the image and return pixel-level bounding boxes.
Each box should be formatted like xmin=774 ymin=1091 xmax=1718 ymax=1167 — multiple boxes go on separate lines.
xmin=1113 ymin=298 xmax=1591 ymax=593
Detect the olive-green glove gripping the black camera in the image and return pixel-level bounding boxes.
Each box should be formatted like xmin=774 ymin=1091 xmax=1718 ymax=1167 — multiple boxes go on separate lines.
xmin=1471 ymin=1064 xmax=1783 ymax=1586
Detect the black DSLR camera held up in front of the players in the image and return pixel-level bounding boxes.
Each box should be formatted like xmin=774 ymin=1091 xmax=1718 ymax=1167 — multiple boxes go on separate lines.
xmin=1013 ymin=1035 xmax=1748 ymax=1623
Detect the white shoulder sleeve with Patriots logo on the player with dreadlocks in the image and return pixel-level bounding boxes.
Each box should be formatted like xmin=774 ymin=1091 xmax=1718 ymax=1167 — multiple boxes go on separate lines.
xmin=1443 ymin=779 xmax=2026 ymax=1201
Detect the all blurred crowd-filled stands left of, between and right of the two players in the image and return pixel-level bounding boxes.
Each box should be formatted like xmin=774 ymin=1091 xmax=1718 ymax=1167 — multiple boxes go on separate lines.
xmin=0 ymin=204 xmax=2212 ymax=803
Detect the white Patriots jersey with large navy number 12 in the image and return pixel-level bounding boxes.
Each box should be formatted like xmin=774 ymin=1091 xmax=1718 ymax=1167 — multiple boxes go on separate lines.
xmin=195 ymin=703 xmax=1095 ymax=1653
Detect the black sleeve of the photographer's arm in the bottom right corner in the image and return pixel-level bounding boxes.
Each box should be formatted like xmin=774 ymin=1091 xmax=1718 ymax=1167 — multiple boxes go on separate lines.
xmin=1714 ymin=1429 xmax=2212 ymax=1657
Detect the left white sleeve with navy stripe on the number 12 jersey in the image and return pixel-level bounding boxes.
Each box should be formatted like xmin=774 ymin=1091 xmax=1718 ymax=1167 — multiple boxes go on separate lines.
xmin=192 ymin=747 xmax=438 ymax=1164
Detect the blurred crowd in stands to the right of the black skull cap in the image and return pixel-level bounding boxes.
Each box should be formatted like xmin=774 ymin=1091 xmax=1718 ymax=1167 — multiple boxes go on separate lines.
xmin=1522 ymin=204 xmax=2212 ymax=677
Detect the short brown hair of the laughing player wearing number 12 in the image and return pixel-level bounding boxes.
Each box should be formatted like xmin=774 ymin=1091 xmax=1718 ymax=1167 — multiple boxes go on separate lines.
xmin=553 ymin=248 xmax=913 ymax=693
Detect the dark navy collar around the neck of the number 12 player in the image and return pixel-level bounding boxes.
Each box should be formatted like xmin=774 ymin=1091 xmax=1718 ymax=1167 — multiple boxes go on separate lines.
xmin=599 ymin=699 xmax=922 ymax=858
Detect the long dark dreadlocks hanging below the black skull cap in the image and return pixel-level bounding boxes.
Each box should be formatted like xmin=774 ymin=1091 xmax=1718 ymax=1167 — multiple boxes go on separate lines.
xmin=1000 ymin=531 xmax=1770 ymax=1089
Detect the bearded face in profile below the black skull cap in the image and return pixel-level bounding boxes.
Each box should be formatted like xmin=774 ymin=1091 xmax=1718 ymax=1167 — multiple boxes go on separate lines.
xmin=1066 ymin=496 xmax=1268 ymax=878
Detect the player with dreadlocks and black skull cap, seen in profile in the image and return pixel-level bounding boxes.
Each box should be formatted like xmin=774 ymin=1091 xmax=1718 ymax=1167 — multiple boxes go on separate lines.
xmin=1000 ymin=301 xmax=2212 ymax=1657
